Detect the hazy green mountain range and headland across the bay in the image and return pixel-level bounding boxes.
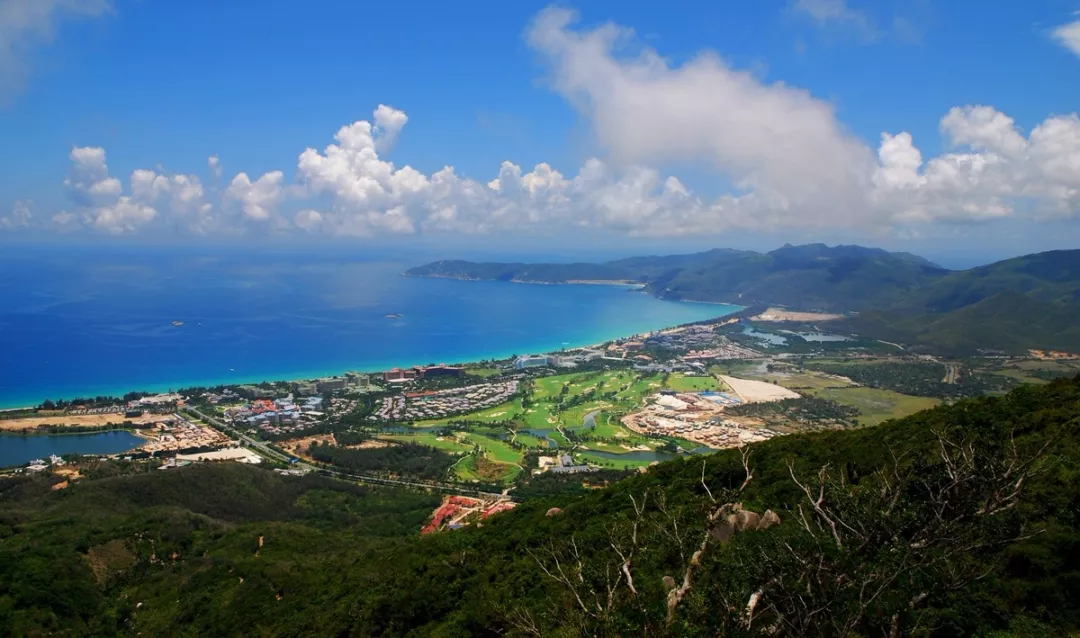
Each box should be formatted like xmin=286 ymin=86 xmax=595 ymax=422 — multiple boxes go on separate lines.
xmin=406 ymin=244 xmax=1080 ymax=354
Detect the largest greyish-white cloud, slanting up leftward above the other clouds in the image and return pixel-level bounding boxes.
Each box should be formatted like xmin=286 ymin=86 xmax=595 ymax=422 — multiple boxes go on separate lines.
xmin=527 ymin=9 xmax=874 ymax=231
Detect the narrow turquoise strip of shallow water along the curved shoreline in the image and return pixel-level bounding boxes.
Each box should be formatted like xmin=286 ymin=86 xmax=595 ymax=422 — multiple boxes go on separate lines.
xmin=0 ymin=300 xmax=745 ymax=411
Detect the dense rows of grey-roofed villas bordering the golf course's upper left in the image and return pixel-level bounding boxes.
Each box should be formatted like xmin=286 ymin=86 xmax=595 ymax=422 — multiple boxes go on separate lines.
xmin=368 ymin=380 xmax=517 ymax=421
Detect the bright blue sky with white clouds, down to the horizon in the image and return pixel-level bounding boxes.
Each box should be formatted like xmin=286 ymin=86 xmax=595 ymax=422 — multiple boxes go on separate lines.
xmin=0 ymin=0 xmax=1080 ymax=264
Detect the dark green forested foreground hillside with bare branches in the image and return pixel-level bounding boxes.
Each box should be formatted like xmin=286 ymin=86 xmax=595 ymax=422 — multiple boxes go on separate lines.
xmin=0 ymin=378 xmax=1080 ymax=637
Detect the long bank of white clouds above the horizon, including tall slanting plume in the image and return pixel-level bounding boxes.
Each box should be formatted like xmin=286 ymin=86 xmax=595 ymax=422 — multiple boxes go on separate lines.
xmin=0 ymin=8 xmax=1080 ymax=236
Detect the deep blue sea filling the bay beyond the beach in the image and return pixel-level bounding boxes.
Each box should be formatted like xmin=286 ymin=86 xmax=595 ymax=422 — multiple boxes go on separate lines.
xmin=0 ymin=245 xmax=738 ymax=407
